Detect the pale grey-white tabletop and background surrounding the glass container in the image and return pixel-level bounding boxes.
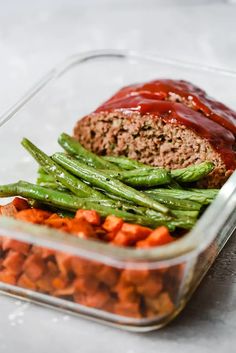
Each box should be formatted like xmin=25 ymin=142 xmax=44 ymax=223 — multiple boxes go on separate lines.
xmin=0 ymin=0 xmax=236 ymax=353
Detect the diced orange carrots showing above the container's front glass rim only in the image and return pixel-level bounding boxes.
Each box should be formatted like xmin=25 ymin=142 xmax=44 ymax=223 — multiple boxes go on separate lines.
xmin=0 ymin=197 xmax=175 ymax=248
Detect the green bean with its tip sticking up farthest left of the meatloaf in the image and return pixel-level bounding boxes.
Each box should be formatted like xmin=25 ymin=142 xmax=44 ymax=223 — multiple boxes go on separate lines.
xmin=22 ymin=138 xmax=101 ymax=197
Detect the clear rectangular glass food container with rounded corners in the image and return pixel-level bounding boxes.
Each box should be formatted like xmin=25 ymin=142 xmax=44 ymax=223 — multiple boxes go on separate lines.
xmin=0 ymin=51 xmax=236 ymax=331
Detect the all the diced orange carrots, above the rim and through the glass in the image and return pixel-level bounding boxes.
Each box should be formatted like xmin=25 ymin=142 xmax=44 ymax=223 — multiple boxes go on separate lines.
xmin=0 ymin=198 xmax=179 ymax=318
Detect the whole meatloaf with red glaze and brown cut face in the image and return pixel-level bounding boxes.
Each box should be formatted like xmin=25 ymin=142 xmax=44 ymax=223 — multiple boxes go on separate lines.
xmin=74 ymin=80 xmax=236 ymax=187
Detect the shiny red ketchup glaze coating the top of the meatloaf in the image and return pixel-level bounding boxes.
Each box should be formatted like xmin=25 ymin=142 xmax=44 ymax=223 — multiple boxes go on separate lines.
xmin=95 ymin=80 xmax=236 ymax=170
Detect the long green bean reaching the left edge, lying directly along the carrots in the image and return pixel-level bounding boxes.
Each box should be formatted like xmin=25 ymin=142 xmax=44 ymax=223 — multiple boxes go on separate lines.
xmin=0 ymin=181 xmax=195 ymax=231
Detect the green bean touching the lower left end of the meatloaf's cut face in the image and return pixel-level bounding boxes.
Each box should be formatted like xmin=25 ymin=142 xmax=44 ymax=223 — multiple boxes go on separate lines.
xmin=58 ymin=133 xmax=119 ymax=170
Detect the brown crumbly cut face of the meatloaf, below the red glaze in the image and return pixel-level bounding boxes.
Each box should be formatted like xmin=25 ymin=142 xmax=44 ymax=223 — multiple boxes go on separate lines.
xmin=75 ymin=112 xmax=231 ymax=187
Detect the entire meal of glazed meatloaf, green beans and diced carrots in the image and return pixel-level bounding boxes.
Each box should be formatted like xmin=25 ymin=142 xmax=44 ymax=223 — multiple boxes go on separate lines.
xmin=0 ymin=80 xmax=236 ymax=318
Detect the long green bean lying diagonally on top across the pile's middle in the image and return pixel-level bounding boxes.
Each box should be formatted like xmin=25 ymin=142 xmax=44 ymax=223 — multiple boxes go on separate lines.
xmin=52 ymin=153 xmax=169 ymax=214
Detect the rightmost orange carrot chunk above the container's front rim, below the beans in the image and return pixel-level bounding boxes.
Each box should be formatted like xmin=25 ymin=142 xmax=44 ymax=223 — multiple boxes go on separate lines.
xmin=136 ymin=226 xmax=175 ymax=248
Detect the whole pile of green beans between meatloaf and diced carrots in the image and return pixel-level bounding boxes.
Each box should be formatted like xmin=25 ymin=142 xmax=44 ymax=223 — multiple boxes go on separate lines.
xmin=0 ymin=133 xmax=218 ymax=231
